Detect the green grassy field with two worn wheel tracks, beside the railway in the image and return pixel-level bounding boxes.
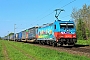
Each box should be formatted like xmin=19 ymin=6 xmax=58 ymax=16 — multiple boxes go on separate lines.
xmin=0 ymin=40 xmax=90 ymax=60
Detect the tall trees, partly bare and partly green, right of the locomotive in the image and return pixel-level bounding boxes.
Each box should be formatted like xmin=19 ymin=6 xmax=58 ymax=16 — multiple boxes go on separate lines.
xmin=71 ymin=4 xmax=90 ymax=39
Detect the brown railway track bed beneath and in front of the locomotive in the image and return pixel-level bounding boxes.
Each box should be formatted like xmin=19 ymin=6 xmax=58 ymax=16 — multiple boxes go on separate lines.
xmin=29 ymin=44 xmax=90 ymax=58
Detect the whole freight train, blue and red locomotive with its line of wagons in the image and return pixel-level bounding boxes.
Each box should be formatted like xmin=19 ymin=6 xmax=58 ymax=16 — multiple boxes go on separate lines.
xmin=3 ymin=20 xmax=77 ymax=46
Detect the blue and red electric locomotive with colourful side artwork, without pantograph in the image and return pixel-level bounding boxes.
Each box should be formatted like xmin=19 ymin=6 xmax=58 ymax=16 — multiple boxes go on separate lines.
xmin=36 ymin=20 xmax=77 ymax=46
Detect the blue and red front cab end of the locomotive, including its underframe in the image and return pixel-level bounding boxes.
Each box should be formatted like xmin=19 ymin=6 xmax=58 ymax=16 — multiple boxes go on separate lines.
xmin=54 ymin=21 xmax=77 ymax=45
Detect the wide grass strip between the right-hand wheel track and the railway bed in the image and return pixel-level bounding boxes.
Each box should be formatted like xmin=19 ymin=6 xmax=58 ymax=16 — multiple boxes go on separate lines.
xmin=9 ymin=42 xmax=90 ymax=60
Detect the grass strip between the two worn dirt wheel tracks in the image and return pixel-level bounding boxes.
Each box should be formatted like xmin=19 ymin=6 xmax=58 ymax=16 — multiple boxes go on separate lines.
xmin=0 ymin=41 xmax=32 ymax=60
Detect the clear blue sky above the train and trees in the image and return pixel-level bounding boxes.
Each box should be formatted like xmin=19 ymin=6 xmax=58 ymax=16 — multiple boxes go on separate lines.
xmin=0 ymin=0 xmax=90 ymax=37
